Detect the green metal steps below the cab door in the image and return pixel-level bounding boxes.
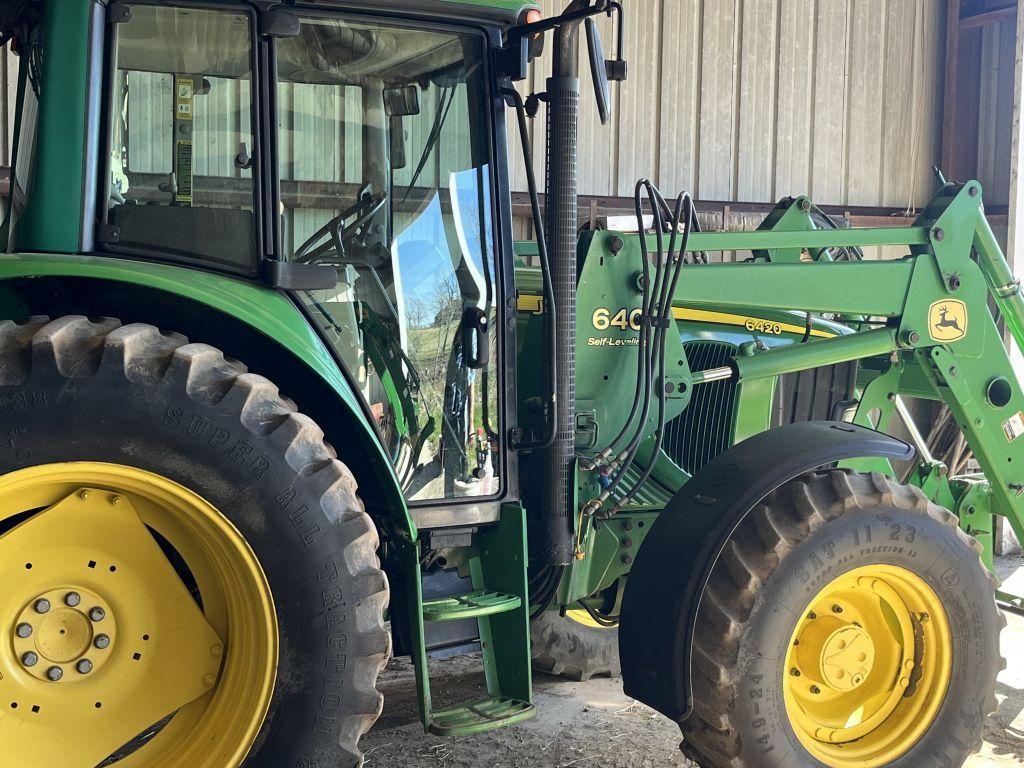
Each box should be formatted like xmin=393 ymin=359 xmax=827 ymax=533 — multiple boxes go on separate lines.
xmin=403 ymin=504 xmax=536 ymax=736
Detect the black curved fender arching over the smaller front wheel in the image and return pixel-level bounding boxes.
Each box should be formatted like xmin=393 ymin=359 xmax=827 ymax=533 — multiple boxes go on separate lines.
xmin=618 ymin=421 xmax=914 ymax=721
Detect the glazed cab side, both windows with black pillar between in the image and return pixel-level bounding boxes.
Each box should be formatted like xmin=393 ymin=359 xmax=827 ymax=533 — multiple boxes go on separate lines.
xmin=99 ymin=4 xmax=502 ymax=502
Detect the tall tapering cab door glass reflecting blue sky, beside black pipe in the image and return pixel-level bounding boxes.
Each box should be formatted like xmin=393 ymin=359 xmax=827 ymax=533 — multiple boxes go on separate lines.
xmin=278 ymin=17 xmax=500 ymax=500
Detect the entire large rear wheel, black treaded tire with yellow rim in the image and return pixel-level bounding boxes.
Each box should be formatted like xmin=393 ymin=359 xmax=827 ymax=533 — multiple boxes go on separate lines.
xmin=0 ymin=316 xmax=390 ymax=768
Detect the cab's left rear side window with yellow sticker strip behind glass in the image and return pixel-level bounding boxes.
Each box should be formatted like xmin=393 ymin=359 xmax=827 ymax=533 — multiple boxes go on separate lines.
xmin=106 ymin=5 xmax=258 ymax=272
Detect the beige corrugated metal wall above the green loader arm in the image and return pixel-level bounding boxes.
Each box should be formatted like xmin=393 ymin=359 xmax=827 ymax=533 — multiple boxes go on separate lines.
xmin=512 ymin=0 xmax=942 ymax=207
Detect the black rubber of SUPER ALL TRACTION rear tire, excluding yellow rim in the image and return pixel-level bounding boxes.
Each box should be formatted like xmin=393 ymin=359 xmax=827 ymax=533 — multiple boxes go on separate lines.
xmin=0 ymin=316 xmax=390 ymax=768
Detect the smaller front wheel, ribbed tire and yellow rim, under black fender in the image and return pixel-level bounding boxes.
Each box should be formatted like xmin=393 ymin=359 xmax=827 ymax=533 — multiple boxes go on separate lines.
xmin=681 ymin=470 xmax=1006 ymax=768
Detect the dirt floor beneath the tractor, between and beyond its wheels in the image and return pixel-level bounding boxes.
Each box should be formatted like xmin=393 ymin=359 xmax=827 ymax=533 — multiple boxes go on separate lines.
xmin=362 ymin=559 xmax=1024 ymax=768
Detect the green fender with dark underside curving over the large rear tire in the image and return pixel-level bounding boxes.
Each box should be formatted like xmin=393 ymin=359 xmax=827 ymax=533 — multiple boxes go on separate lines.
xmin=0 ymin=254 xmax=417 ymax=539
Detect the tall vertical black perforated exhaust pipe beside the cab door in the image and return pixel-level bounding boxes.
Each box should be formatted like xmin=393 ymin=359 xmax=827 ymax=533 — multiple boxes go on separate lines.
xmin=531 ymin=9 xmax=589 ymax=565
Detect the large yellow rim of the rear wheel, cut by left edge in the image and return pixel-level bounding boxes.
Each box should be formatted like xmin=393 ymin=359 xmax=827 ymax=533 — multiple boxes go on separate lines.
xmin=0 ymin=462 xmax=278 ymax=768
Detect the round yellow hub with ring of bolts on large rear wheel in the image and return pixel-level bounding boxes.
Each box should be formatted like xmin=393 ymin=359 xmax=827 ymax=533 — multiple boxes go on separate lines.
xmin=11 ymin=586 xmax=117 ymax=684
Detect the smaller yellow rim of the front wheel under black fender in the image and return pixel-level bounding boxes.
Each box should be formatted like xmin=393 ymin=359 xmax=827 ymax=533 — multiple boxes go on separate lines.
xmin=782 ymin=564 xmax=952 ymax=768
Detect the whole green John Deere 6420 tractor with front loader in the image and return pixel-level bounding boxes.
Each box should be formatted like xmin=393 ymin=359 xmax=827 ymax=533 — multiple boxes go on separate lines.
xmin=0 ymin=0 xmax=1024 ymax=768
